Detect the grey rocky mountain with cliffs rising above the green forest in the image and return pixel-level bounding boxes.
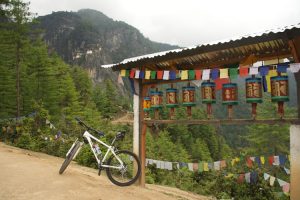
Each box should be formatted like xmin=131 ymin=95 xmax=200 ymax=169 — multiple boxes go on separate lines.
xmin=38 ymin=9 xmax=178 ymax=82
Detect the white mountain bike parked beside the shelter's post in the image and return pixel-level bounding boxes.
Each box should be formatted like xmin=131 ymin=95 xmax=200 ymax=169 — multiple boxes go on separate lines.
xmin=59 ymin=118 xmax=141 ymax=186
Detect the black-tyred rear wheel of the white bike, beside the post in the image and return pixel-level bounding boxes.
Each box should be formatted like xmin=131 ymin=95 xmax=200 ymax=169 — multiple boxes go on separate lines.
xmin=106 ymin=150 xmax=141 ymax=186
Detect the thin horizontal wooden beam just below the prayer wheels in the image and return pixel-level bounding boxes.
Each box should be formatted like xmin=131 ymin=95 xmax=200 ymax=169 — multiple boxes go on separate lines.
xmin=144 ymin=118 xmax=300 ymax=126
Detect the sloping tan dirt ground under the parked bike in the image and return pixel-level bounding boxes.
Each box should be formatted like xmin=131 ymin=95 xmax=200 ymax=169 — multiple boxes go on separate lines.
xmin=0 ymin=143 xmax=210 ymax=200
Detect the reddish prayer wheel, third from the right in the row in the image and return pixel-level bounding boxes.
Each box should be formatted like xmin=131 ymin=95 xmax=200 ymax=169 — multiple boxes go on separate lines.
xmin=222 ymin=83 xmax=238 ymax=119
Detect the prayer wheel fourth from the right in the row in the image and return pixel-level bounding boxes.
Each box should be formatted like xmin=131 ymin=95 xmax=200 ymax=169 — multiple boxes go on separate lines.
xmin=201 ymin=82 xmax=216 ymax=118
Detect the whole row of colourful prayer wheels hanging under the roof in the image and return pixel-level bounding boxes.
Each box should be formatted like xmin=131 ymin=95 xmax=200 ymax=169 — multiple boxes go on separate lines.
xmin=144 ymin=76 xmax=289 ymax=119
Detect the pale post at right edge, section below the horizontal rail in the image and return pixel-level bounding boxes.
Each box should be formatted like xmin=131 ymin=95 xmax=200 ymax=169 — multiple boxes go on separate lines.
xmin=290 ymin=125 xmax=300 ymax=200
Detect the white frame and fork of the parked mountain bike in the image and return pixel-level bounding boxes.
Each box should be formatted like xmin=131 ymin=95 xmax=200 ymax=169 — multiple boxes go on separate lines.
xmin=66 ymin=131 xmax=124 ymax=169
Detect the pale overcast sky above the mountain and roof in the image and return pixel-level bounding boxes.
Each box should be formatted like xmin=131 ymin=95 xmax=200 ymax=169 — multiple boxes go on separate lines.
xmin=30 ymin=0 xmax=300 ymax=46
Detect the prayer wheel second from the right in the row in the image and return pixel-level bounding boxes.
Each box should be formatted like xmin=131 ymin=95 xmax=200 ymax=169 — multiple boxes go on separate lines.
xmin=246 ymin=77 xmax=262 ymax=119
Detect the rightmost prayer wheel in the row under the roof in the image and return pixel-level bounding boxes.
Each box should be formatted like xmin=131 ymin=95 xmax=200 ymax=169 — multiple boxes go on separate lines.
xmin=271 ymin=76 xmax=289 ymax=118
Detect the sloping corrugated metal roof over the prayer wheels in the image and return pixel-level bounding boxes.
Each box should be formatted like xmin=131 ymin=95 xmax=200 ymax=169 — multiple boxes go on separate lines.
xmin=109 ymin=23 xmax=300 ymax=70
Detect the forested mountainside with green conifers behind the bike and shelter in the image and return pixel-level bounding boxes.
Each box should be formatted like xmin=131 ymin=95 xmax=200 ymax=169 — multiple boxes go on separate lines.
xmin=0 ymin=0 xmax=296 ymax=200
